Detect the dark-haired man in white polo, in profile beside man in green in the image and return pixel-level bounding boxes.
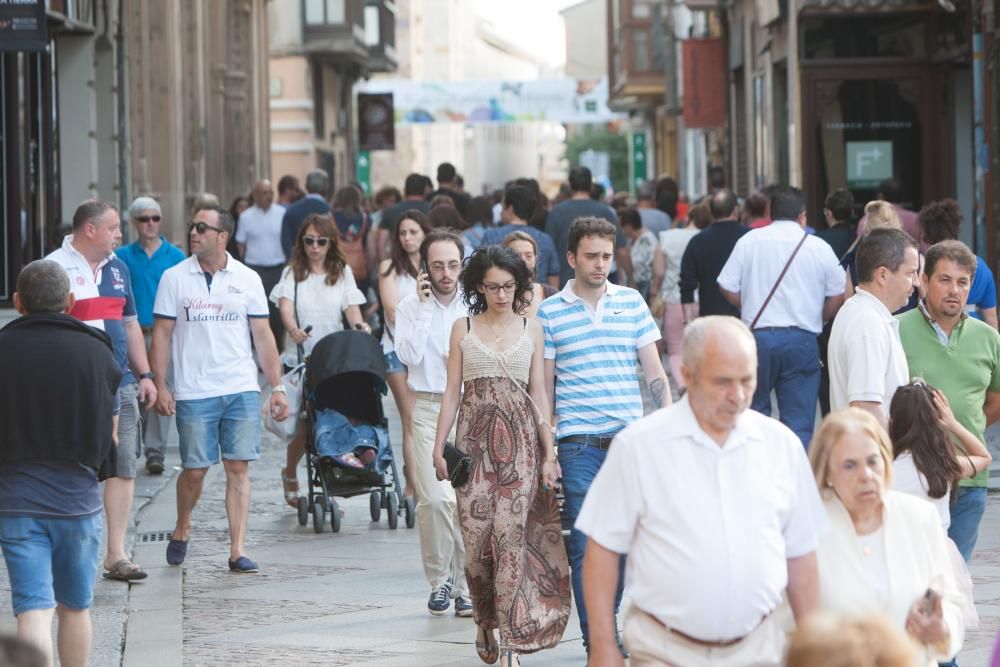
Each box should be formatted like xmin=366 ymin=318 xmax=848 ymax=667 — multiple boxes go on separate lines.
xmin=829 ymin=229 xmax=920 ymax=427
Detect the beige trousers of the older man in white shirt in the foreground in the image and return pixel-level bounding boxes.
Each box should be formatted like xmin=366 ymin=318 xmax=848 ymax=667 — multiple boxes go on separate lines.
xmin=623 ymin=606 xmax=786 ymax=667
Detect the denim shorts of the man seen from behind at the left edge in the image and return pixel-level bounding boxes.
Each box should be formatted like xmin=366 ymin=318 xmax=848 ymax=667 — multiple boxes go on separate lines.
xmin=0 ymin=512 xmax=104 ymax=616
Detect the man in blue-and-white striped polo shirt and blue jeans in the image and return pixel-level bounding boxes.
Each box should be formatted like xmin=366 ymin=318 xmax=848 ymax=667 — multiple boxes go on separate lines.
xmin=538 ymin=218 xmax=670 ymax=646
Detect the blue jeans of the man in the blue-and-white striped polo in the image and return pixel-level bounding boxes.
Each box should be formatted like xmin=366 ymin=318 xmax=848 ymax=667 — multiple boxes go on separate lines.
xmin=559 ymin=442 xmax=625 ymax=643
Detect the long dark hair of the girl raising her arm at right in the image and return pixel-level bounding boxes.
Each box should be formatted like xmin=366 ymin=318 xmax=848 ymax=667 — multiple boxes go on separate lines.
xmin=889 ymin=379 xmax=962 ymax=498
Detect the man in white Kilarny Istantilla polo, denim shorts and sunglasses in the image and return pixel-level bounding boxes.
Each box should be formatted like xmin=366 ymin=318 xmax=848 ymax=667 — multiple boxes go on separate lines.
xmin=152 ymin=207 xmax=288 ymax=573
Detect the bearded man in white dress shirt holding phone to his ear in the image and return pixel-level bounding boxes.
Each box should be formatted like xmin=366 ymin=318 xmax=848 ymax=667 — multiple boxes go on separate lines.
xmin=396 ymin=230 xmax=472 ymax=616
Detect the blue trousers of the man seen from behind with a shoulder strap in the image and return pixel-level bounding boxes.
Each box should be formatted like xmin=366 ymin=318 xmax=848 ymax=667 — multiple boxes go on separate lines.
xmin=750 ymin=327 xmax=820 ymax=448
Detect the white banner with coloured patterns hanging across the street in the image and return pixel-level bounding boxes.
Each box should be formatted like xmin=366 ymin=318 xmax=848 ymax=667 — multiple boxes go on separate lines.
xmin=358 ymin=78 xmax=626 ymax=124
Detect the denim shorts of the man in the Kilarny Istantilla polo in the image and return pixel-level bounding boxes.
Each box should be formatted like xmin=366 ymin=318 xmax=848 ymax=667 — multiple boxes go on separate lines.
xmin=177 ymin=391 xmax=260 ymax=468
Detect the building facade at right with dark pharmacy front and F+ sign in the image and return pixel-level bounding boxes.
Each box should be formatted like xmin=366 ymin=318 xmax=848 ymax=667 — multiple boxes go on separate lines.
xmin=724 ymin=0 xmax=997 ymax=264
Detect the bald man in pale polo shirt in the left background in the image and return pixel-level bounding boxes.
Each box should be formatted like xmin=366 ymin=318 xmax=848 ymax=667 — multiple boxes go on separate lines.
xmin=236 ymin=179 xmax=288 ymax=350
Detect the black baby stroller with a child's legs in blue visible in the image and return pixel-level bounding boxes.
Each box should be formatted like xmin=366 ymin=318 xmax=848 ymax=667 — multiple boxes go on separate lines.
xmin=298 ymin=330 xmax=416 ymax=533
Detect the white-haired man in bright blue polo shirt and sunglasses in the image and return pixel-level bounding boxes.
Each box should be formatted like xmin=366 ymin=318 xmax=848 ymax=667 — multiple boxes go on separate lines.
xmin=115 ymin=197 xmax=184 ymax=475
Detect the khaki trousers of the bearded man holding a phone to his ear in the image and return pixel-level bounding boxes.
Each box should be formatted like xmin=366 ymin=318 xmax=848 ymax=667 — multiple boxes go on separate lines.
xmin=410 ymin=394 xmax=469 ymax=597
